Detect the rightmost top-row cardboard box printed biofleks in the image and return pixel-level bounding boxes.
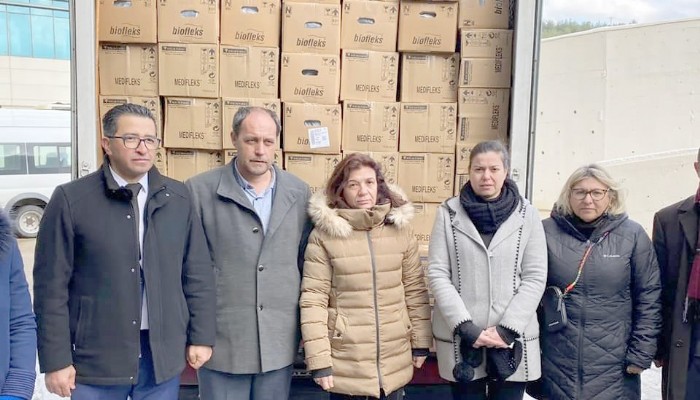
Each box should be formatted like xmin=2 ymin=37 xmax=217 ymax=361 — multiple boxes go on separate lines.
xmin=399 ymin=1 xmax=457 ymax=53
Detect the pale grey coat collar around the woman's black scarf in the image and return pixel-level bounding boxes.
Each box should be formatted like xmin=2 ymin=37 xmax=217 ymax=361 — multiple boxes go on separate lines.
xmin=445 ymin=197 xmax=529 ymax=249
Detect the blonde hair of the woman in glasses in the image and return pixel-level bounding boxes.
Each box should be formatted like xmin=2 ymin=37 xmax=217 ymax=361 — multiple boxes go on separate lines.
xmin=554 ymin=164 xmax=625 ymax=215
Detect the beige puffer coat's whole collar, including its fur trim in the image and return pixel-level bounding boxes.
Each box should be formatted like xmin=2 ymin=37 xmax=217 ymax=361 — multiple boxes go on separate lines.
xmin=309 ymin=185 xmax=415 ymax=238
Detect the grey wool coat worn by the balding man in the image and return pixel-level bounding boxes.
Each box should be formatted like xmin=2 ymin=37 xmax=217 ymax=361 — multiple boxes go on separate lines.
xmin=187 ymin=159 xmax=311 ymax=374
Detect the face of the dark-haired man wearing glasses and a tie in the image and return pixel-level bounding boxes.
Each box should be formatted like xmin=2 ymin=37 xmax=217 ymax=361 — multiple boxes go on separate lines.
xmin=102 ymin=114 xmax=156 ymax=183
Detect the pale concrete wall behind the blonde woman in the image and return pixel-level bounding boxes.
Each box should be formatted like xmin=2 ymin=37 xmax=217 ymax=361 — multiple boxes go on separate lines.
xmin=533 ymin=19 xmax=700 ymax=228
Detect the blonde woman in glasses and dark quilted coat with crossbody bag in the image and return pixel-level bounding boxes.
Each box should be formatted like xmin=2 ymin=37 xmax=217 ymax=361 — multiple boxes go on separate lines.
xmin=542 ymin=164 xmax=661 ymax=400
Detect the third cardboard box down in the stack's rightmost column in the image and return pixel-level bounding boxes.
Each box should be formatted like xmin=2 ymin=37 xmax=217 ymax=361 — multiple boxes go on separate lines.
xmin=459 ymin=58 xmax=512 ymax=88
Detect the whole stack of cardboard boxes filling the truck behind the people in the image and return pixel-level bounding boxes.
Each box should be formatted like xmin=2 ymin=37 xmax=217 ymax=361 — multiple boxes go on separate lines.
xmin=96 ymin=0 xmax=513 ymax=223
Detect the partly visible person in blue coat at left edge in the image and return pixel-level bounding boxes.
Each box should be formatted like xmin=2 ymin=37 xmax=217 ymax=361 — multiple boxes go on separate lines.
xmin=0 ymin=210 xmax=36 ymax=400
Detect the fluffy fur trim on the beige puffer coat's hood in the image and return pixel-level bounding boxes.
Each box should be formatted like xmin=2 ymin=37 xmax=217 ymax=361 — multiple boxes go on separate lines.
xmin=308 ymin=185 xmax=415 ymax=238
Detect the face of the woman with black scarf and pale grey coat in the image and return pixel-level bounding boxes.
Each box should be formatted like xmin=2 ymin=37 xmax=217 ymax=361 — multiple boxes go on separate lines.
xmin=469 ymin=151 xmax=508 ymax=200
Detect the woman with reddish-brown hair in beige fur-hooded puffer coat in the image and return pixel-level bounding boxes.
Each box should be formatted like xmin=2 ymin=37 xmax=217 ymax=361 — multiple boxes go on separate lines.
xmin=300 ymin=153 xmax=432 ymax=400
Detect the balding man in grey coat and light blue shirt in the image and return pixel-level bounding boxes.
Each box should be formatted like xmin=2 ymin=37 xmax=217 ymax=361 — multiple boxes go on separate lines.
xmin=187 ymin=107 xmax=311 ymax=400
